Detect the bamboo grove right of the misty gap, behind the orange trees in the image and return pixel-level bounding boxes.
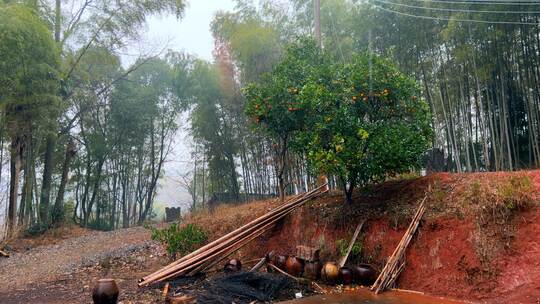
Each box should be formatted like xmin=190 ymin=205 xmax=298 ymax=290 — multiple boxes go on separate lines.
xmin=185 ymin=0 xmax=540 ymax=209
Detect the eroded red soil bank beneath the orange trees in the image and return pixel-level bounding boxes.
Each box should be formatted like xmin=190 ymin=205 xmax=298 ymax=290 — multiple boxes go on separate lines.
xmin=189 ymin=171 xmax=540 ymax=303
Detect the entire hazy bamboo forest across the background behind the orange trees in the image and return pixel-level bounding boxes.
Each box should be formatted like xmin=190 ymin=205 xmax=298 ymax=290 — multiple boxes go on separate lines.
xmin=0 ymin=0 xmax=540 ymax=236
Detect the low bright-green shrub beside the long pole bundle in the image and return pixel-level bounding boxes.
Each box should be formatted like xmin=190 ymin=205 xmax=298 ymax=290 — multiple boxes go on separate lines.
xmin=150 ymin=223 xmax=208 ymax=258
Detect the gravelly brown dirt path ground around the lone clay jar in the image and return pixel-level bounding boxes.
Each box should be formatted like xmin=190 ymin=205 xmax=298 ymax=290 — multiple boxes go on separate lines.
xmin=0 ymin=227 xmax=168 ymax=304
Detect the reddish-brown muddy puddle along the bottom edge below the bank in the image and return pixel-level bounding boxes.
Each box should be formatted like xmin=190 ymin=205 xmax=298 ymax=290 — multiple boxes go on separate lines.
xmin=281 ymin=289 xmax=468 ymax=304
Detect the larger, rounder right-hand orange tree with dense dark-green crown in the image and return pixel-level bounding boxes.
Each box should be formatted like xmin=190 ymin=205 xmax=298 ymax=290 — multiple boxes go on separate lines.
xmin=298 ymin=54 xmax=432 ymax=202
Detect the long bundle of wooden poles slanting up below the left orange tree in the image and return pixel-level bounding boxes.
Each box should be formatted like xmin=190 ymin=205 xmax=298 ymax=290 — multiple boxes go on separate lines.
xmin=139 ymin=184 xmax=328 ymax=287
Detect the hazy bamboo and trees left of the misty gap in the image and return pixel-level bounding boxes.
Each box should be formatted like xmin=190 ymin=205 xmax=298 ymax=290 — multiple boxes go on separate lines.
xmin=0 ymin=0 xmax=185 ymax=234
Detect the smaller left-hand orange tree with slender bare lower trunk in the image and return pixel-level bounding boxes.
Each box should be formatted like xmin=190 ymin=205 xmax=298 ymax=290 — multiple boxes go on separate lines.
xmin=243 ymin=39 xmax=330 ymax=200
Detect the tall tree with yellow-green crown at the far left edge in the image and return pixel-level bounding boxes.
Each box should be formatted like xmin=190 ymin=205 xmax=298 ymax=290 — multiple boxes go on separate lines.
xmin=0 ymin=5 xmax=60 ymax=234
